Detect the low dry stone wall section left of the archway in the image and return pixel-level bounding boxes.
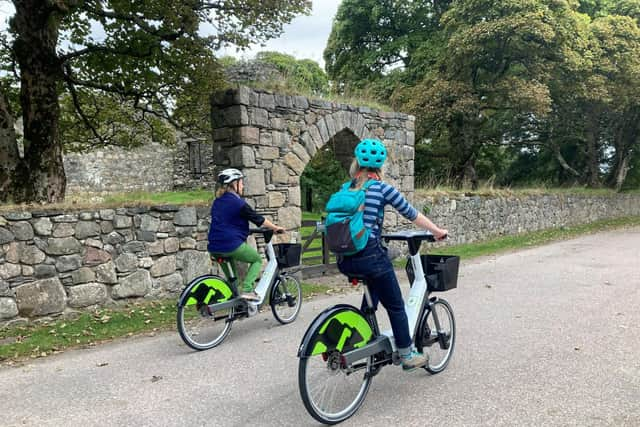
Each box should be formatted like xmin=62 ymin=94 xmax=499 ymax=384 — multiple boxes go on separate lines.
xmin=0 ymin=206 xmax=211 ymax=323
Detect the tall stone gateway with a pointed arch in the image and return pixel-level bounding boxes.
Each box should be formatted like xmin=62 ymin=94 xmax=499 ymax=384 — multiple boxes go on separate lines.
xmin=211 ymin=87 xmax=415 ymax=229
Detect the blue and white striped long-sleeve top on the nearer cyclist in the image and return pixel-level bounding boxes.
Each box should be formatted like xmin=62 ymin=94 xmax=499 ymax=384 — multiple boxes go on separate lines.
xmin=364 ymin=181 xmax=418 ymax=239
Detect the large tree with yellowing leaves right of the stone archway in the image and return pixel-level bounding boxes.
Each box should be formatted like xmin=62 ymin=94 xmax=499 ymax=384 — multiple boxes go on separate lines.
xmin=406 ymin=0 xmax=572 ymax=186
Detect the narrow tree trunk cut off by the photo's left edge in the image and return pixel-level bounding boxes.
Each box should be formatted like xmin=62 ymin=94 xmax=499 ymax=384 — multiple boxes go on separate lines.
xmin=0 ymin=93 xmax=20 ymax=203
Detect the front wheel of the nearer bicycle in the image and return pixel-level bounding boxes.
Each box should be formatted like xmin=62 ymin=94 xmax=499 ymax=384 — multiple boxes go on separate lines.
xmin=416 ymin=299 xmax=456 ymax=374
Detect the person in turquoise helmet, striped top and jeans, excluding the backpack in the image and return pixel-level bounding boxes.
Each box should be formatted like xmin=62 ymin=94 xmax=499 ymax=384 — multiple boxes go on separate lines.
xmin=338 ymin=139 xmax=448 ymax=370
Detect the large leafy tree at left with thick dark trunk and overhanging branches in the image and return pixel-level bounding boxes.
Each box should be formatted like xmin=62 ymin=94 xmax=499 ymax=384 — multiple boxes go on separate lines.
xmin=0 ymin=0 xmax=310 ymax=202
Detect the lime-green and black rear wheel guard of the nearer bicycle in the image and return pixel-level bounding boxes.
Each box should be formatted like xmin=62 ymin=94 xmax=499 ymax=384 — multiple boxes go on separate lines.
xmin=298 ymin=304 xmax=373 ymax=357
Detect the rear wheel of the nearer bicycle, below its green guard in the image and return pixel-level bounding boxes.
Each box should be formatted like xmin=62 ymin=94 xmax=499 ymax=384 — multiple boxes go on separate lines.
xmin=298 ymin=350 xmax=373 ymax=424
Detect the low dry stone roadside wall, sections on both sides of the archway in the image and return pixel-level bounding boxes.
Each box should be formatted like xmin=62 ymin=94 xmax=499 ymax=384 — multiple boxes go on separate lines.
xmin=0 ymin=192 xmax=640 ymax=325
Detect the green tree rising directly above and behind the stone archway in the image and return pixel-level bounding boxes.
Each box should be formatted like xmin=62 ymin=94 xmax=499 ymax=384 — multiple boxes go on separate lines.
xmin=324 ymin=0 xmax=451 ymax=93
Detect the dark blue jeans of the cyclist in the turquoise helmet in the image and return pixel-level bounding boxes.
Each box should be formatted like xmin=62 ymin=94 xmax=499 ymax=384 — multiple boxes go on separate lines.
xmin=338 ymin=240 xmax=411 ymax=349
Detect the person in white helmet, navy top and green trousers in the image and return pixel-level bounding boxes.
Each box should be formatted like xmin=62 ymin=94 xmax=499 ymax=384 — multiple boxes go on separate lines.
xmin=207 ymin=168 xmax=284 ymax=301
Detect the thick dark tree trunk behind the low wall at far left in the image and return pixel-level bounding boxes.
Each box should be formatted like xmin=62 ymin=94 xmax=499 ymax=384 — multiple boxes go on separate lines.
xmin=11 ymin=0 xmax=66 ymax=202
